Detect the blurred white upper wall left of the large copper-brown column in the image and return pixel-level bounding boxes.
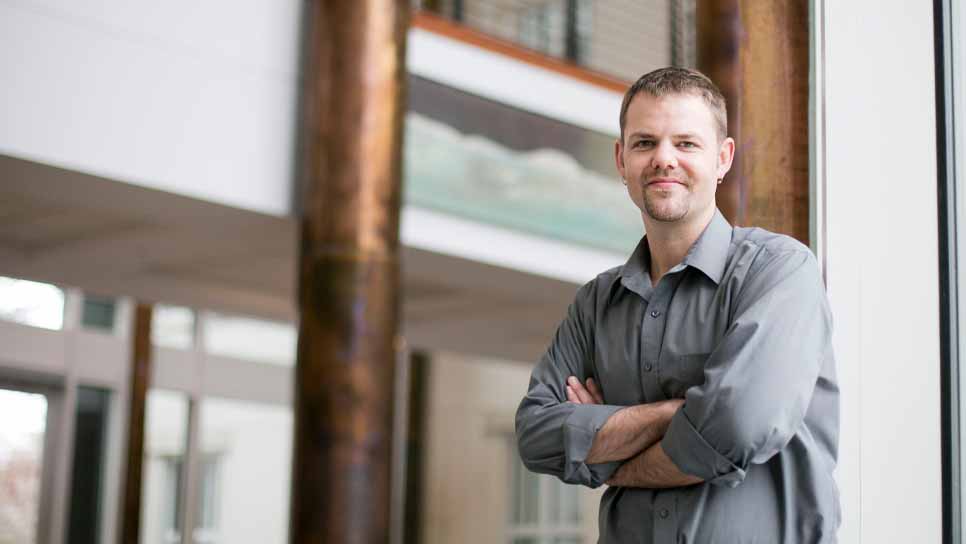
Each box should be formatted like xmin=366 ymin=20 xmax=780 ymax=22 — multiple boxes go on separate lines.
xmin=0 ymin=0 xmax=302 ymax=215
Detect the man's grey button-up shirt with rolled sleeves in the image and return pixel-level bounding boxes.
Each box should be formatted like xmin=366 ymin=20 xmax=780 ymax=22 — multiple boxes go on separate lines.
xmin=516 ymin=212 xmax=840 ymax=544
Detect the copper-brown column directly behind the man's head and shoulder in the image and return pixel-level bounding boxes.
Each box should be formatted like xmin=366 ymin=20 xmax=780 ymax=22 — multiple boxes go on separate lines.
xmin=696 ymin=0 xmax=809 ymax=244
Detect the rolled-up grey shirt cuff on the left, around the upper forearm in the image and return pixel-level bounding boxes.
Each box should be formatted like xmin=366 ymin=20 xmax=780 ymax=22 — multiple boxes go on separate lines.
xmin=563 ymin=404 xmax=624 ymax=487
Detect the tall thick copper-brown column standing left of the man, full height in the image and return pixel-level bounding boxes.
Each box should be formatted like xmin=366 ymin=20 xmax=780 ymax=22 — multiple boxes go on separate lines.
xmin=290 ymin=0 xmax=409 ymax=544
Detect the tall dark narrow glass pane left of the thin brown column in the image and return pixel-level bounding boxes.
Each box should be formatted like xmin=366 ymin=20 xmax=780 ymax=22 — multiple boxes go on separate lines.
xmin=66 ymin=387 xmax=110 ymax=544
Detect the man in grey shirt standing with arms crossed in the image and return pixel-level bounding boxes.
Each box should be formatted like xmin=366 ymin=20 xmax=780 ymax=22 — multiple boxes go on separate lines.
xmin=516 ymin=68 xmax=840 ymax=544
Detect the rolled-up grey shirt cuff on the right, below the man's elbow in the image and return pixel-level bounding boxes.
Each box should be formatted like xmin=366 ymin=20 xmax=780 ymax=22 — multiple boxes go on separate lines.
xmin=661 ymin=409 xmax=745 ymax=487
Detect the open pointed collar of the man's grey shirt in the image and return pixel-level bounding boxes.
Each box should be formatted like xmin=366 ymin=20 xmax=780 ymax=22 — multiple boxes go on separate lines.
xmin=621 ymin=209 xmax=733 ymax=298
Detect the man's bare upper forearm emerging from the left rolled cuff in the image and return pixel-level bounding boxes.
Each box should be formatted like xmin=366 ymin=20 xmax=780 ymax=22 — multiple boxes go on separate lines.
xmin=587 ymin=400 xmax=681 ymax=463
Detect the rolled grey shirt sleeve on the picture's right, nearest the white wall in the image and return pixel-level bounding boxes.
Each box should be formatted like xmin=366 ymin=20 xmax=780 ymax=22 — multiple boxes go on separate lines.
xmin=661 ymin=244 xmax=832 ymax=487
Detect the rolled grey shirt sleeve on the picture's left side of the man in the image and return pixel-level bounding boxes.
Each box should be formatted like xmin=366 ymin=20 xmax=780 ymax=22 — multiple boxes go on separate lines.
xmin=516 ymin=284 xmax=623 ymax=487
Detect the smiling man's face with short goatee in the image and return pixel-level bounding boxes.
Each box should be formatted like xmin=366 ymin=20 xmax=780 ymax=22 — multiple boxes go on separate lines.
xmin=616 ymin=93 xmax=735 ymax=223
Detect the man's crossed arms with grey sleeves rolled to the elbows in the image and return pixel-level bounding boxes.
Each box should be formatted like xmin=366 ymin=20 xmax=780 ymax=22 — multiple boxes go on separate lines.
xmin=516 ymin=245 xmax=831 ymax=488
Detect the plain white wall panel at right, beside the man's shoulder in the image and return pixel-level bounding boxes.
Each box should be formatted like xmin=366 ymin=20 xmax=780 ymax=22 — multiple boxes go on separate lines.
xmin=816 ymin=0 xmax=942 ymax=544
